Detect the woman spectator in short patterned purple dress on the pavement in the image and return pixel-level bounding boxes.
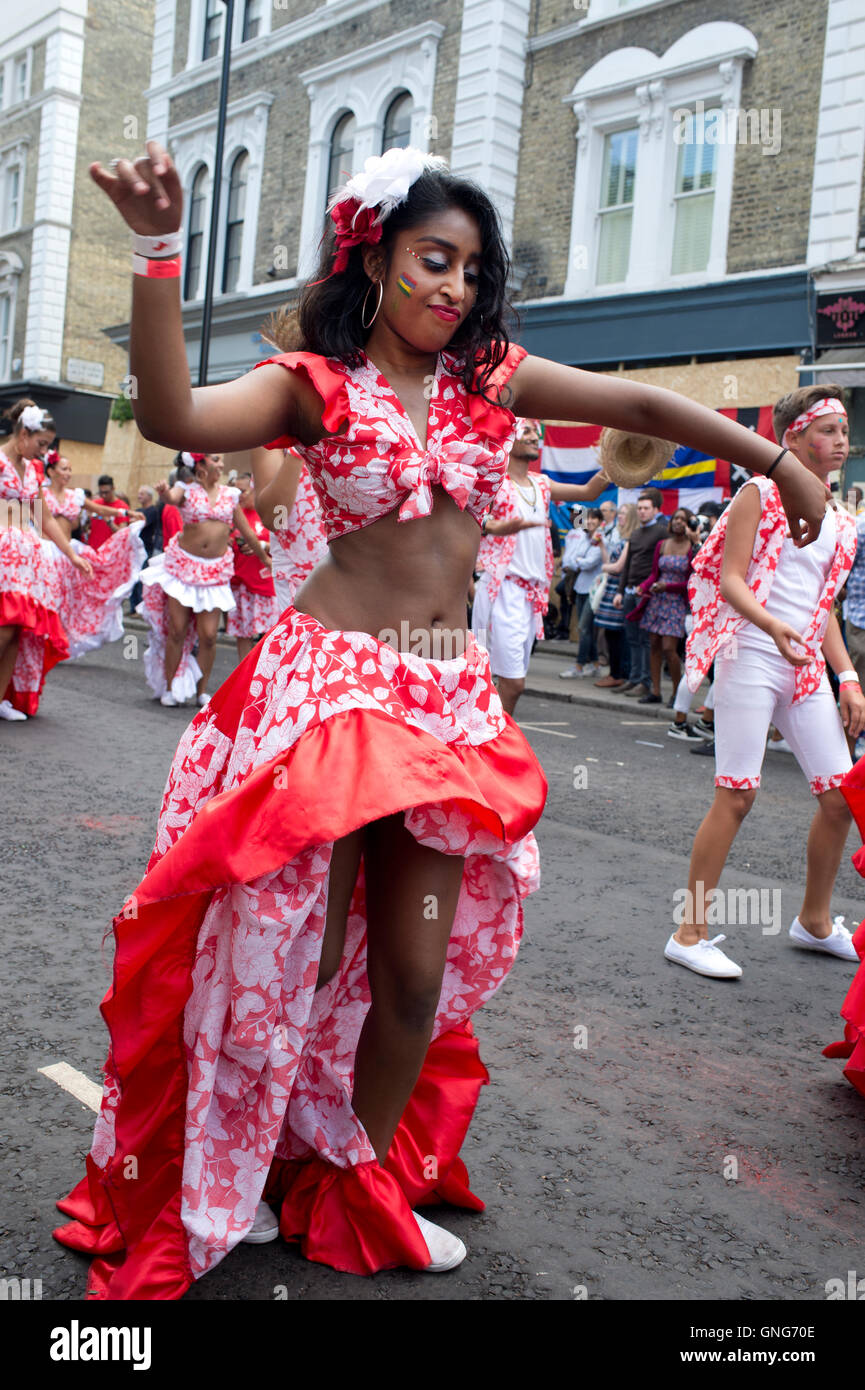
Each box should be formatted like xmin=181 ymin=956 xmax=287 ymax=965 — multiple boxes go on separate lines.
xmin=626 ymin=507 xmax=694 ymax=705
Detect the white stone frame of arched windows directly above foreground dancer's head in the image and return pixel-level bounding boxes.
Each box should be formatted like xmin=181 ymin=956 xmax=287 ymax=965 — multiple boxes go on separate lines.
xmin=298 ymin=19 xmax=445 ymax=278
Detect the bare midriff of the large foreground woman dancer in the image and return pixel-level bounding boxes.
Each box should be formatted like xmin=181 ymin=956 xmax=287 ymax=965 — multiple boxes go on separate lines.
xmin=295 ymin=487 xmax=481 ymax=660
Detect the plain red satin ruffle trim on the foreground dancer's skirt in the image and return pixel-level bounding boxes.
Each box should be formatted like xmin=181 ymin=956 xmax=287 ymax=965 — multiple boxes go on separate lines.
xmin=54 ymin=695 xmax=547 ymax=1300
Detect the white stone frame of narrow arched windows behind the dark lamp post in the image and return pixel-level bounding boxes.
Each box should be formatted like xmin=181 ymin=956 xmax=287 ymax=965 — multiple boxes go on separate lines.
xmin=168 ymin=92 xmax=275 ymax=304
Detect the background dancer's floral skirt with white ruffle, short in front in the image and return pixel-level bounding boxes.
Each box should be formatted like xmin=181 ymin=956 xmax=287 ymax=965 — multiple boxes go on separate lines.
xmin=138 ymin=535 xmax=235 ymax=701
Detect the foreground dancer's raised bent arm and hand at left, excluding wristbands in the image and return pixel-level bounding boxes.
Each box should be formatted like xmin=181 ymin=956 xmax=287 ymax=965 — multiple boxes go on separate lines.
xmin=90 ymin=140 xmax=321 ymax=453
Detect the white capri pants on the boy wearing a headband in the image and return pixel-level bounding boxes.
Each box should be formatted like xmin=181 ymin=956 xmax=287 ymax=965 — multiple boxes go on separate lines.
xmin=715 ymin=641 xmax=852 ymax=796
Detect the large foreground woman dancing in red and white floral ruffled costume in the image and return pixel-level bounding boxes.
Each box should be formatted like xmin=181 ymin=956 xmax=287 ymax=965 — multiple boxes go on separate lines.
xmin=52 ymin=140 xmax=823 ymax=1298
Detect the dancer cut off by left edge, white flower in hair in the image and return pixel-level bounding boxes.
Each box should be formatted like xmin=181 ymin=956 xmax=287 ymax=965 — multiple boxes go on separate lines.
xmin=0 ymin=400 xmax=93 ymax=720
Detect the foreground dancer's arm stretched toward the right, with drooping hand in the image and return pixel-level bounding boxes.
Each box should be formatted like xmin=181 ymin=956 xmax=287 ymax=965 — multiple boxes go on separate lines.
xmin=510 ymin=356 xmax=826 ymax=545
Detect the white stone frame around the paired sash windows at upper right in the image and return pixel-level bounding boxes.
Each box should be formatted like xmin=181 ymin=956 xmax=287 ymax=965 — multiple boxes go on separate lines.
xmin=565 ymin=21 xmax=758 ymax=299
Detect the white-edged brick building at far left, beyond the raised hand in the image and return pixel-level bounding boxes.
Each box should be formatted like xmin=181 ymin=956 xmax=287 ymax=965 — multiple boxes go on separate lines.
xmin=0 ymin=0 xmax=153 ymax=482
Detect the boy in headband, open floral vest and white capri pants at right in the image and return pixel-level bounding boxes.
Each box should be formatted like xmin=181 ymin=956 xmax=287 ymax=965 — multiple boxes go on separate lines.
xmin=663 ymin=385 xmax=865 ymax=979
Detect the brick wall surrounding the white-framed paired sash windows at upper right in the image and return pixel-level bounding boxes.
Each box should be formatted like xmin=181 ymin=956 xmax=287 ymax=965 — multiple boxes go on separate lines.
xmin=515 ymin=0 xmax=826 ymax=299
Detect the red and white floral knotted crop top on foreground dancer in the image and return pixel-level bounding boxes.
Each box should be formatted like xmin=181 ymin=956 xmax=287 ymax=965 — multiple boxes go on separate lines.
xmin=256 ymin=343 xmax=526 ymax=541
